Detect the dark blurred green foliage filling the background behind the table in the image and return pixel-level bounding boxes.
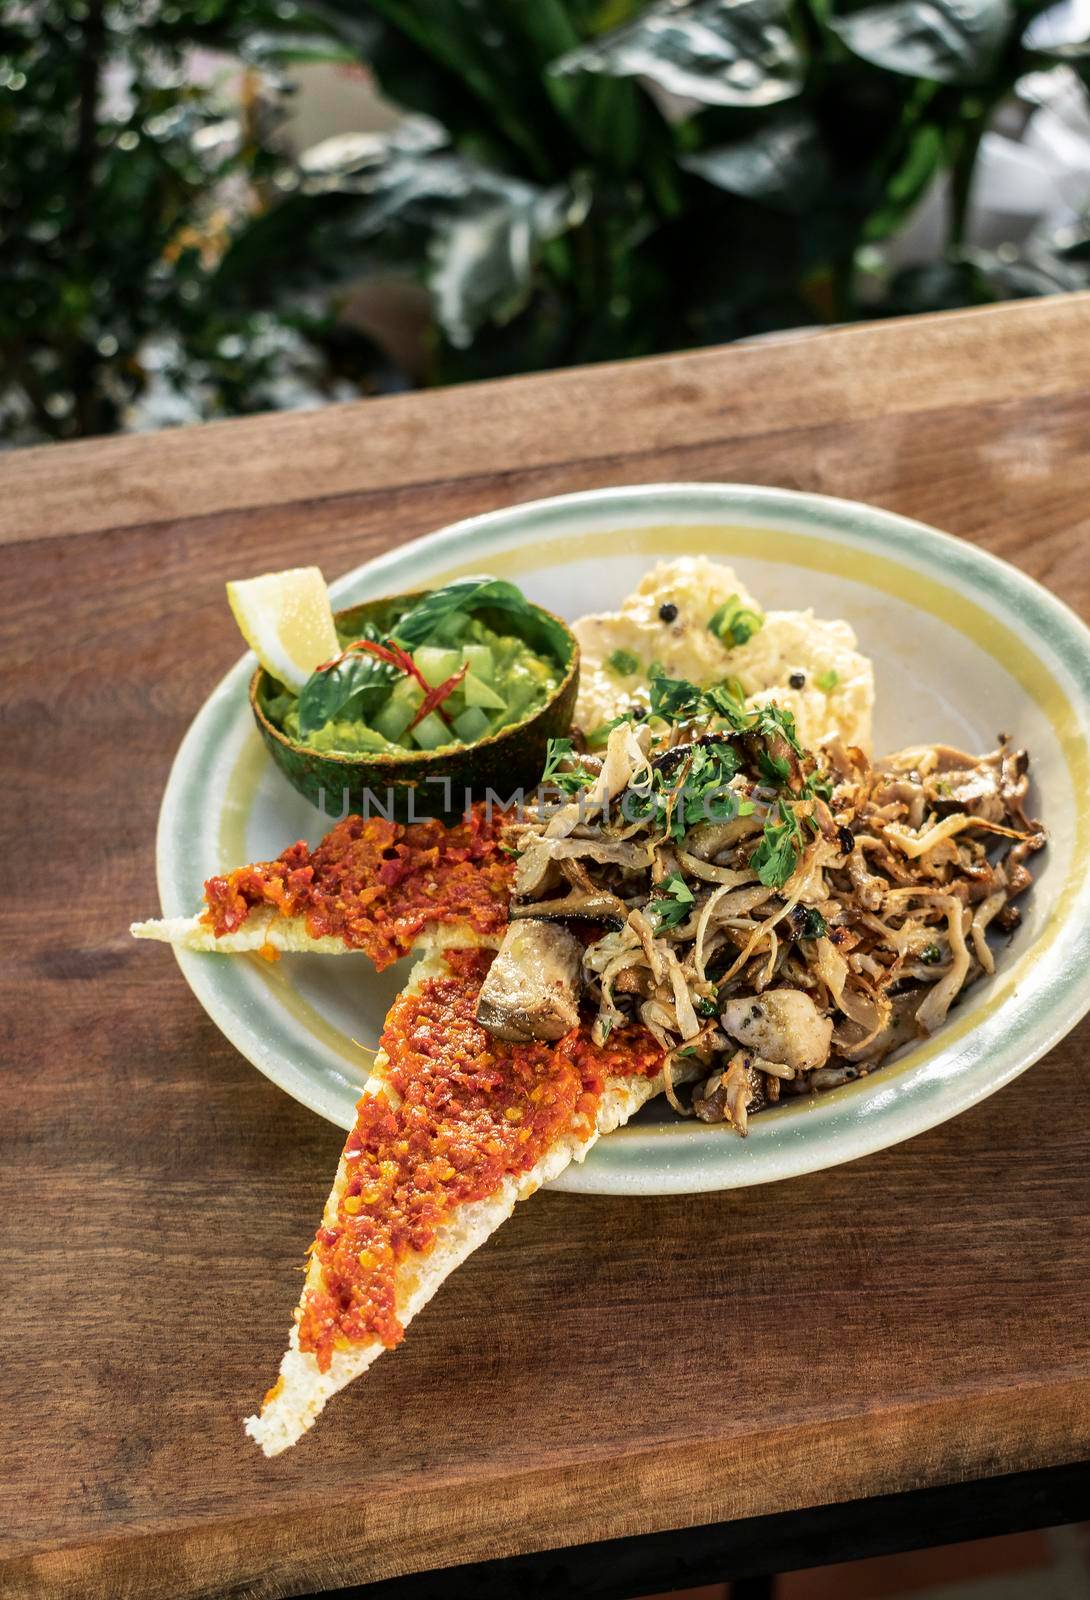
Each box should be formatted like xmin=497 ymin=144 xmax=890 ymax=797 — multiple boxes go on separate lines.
xmin=0 ymin=0 xmax=1090 ymax=437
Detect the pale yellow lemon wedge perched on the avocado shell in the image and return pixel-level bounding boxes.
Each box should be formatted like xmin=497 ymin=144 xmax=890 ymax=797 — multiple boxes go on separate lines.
xmin=227 ymin=566 xmax=341 ymax=694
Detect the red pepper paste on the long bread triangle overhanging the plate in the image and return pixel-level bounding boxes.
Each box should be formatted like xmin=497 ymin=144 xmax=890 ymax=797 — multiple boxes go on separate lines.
xmin=292 ymin=950 xmax=663 ymax=1371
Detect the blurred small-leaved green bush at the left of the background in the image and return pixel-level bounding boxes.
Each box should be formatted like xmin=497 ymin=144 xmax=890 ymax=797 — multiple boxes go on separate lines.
xmin=0 ymin=0 xmax=380 ymax=442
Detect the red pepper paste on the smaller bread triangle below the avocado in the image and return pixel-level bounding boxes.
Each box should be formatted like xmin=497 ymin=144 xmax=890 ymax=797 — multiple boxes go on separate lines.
xmin=202 ymin=802 xmax=514 ymax=971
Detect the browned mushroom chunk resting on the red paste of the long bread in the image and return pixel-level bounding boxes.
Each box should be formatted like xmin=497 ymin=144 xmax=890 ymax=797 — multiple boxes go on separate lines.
xmin=477 ymin=922 xmax=583 ymax=1043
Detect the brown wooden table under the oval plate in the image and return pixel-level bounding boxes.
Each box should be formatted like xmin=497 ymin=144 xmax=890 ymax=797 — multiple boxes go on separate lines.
xmin=0 ymin=298 xmax=1090 ymax=1600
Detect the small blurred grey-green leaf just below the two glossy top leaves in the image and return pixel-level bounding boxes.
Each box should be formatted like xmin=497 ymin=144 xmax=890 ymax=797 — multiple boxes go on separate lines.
xmin=680 ymin=109 xmax=829 ymax=211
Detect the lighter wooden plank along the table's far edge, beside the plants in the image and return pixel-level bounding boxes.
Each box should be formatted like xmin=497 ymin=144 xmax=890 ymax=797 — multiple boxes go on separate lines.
xmin=0 ymin=291 xmax=1090 ymax=544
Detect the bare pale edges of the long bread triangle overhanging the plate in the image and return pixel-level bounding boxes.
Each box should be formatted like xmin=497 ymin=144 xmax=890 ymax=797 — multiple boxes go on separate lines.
xmin=245 ymin=930 xmax=675 ymax=1456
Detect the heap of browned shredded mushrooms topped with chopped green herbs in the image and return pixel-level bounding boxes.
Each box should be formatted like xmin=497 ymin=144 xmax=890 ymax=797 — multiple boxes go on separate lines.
xmin=489 ymin=706 xmax=1045 ymax=1134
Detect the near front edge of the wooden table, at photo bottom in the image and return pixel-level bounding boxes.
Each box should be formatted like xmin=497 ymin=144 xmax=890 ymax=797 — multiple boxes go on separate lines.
xmin=8 ymin=1370 xmax=1090 ymax=1600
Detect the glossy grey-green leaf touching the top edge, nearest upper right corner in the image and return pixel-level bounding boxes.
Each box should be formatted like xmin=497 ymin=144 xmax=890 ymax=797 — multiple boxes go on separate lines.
xmin=829 ymin=0 xmax=1015 ymax=83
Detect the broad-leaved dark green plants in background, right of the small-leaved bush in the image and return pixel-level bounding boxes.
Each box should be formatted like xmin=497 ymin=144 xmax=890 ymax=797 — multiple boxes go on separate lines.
xmin=222 ymin=0 xmax=1090 ymax=381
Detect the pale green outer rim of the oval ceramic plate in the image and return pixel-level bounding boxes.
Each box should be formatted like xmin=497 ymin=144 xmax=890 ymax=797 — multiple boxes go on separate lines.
xmin=155 ymin=482 xmax=1090 ymax=1195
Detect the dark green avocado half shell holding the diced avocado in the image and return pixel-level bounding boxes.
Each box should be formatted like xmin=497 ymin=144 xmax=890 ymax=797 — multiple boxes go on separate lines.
xmin=250 ymin=592 xmax=579 ymax=819
